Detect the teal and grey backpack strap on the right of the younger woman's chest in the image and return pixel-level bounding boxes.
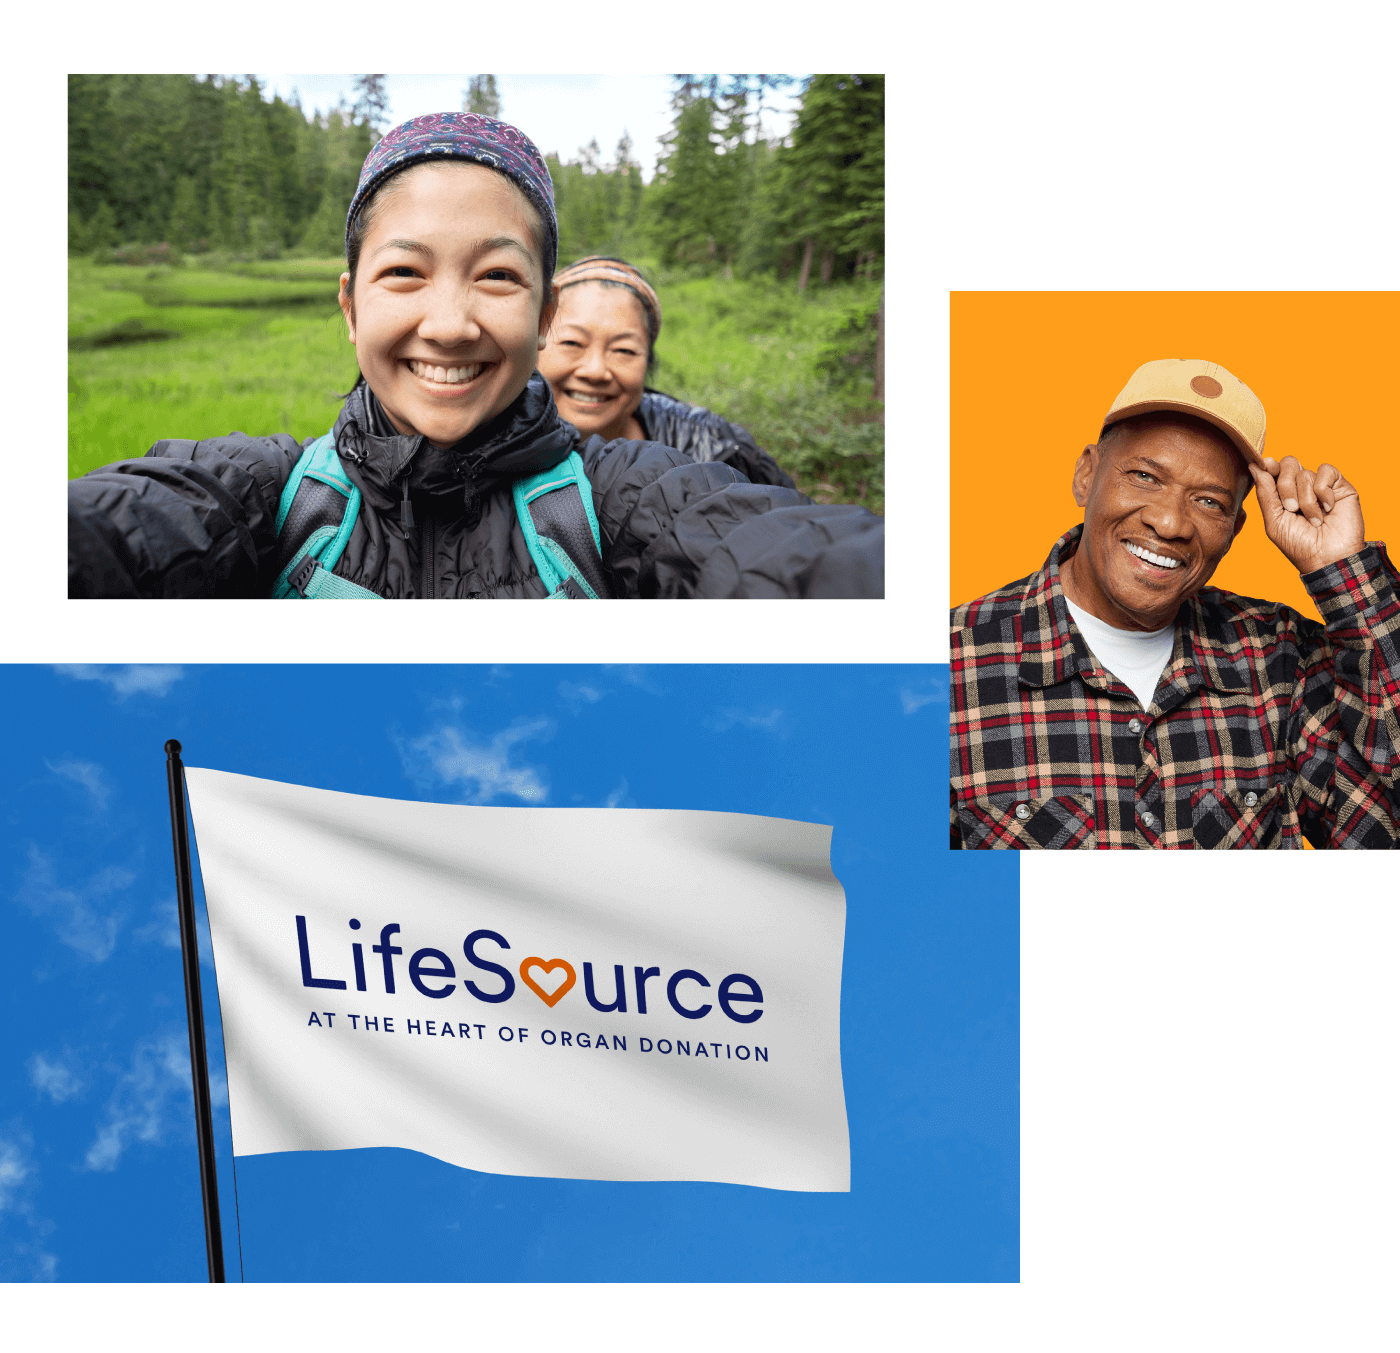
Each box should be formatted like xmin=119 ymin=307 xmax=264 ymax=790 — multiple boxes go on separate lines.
xmin=511 ymin=451 xmax=612 ymax=601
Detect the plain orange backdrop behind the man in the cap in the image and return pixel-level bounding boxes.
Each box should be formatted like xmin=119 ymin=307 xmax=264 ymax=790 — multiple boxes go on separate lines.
xmin=948 ymin=291 xmax=1400 ymax=620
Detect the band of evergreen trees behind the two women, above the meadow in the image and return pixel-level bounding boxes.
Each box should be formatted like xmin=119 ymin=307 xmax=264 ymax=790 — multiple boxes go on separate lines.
xmin=67 ymin=74 xmax=885 ymax=286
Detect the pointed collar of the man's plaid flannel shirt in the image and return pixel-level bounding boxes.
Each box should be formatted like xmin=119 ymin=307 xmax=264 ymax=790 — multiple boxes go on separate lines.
xmin=1019 ymin=521 xmax=1250 ymax=692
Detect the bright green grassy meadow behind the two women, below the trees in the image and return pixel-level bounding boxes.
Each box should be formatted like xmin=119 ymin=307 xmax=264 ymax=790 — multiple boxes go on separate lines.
xmin=67 ymin=258 xmax=885 ymax=513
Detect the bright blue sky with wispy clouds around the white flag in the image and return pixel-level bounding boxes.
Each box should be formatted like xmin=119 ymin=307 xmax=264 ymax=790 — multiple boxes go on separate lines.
xmin=0 ymin=664 xmax=1019 ymax=1282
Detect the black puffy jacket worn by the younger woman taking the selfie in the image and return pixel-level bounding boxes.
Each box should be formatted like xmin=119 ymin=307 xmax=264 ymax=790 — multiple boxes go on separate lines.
xmin=69 ymin=373 xmax=885 ymax=601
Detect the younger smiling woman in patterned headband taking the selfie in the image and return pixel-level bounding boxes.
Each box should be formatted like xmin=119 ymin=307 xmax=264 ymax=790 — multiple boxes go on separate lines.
xmin=69 ymin=113 xmax=885 ymax=601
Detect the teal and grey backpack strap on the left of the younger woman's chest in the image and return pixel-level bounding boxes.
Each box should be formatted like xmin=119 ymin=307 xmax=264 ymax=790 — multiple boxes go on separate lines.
xmin=272 ymin=433 xmax=384 ymax=601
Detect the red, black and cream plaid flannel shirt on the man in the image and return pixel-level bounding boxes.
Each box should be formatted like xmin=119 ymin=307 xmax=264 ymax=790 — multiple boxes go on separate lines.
xmin=948 ymin=522 xmax=1400 ymax=850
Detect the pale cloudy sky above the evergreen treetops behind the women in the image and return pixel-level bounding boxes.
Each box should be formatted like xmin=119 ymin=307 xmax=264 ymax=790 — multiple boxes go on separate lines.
xmin=246 ymin=74 xmax=804 ymax=183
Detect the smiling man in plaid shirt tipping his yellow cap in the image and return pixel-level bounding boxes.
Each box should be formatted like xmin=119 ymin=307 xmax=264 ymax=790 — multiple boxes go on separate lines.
xmin=948 ymin=359 xmax=1400 ymax=850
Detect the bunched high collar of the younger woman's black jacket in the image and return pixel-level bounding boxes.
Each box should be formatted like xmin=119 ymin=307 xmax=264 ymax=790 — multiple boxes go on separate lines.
xmin=333 ymin=371 xmax=578 ymax=511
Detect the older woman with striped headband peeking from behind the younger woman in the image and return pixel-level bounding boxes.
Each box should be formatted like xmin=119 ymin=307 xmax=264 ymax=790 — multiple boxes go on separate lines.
xmin=539 ymin=255 xmax=795 ymax=489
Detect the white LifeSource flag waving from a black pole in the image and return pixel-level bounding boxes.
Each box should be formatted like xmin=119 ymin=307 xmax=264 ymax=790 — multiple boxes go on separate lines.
xmin=185 ymin=768 xmax=850 ymax=1192
